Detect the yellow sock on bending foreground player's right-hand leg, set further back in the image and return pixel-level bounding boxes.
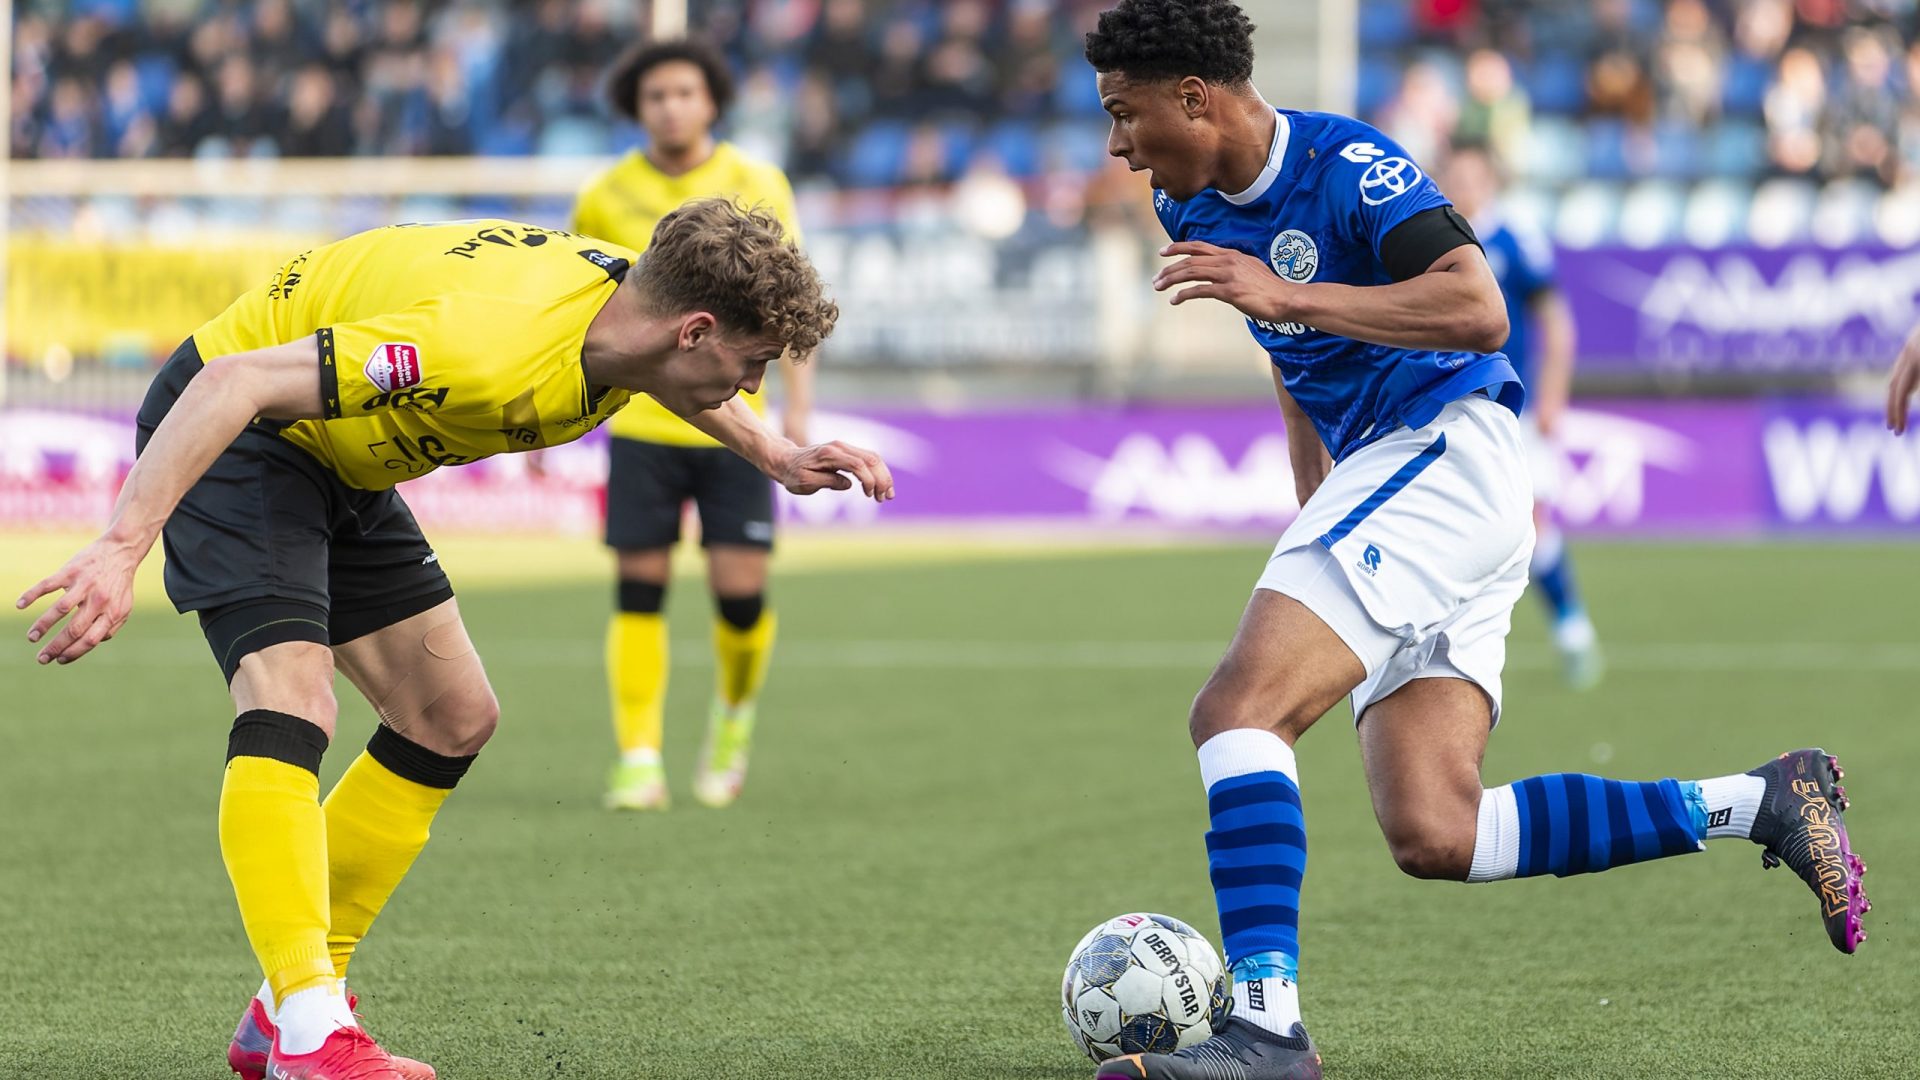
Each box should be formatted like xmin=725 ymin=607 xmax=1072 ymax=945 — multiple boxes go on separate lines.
xmin=324 ymin=751 xmax=453 ymax=978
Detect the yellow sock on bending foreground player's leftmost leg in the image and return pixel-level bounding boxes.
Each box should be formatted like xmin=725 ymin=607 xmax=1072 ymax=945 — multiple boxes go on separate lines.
xmin=219 ymin=755 xmax=334 ymax=1001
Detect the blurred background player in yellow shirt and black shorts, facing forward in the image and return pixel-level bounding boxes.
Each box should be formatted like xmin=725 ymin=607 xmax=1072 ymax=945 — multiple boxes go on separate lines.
xmin=574 ymin=40 xmax=812 ymax=809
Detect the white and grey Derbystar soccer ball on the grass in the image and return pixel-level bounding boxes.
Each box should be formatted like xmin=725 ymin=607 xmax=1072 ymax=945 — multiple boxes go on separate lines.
xmin=1060 ymin=913 xmax=1233 ymax=1061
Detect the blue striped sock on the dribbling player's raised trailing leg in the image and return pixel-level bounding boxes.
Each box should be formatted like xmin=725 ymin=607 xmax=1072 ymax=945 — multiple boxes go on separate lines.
xmin=1488 ymin=773 xmax=1705 ymax=878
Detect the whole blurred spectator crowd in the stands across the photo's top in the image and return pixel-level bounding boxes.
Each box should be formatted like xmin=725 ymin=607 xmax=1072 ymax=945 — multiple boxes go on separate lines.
xmin=12 ymin=0 xmax=1920 ymax=186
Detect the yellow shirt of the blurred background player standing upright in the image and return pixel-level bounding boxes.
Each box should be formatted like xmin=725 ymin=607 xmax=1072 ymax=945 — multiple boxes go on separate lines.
xmin=572 ymin=142 xmax=801 ymax=446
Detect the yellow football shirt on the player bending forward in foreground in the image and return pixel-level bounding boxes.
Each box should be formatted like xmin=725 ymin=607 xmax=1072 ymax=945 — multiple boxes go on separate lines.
xmin=194 ymin=219 xmax=651 ymax=490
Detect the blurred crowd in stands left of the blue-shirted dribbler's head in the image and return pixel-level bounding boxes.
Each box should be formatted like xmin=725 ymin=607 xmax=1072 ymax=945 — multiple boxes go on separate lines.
xmin=12 ymin=0 xmax=1102 ymax=184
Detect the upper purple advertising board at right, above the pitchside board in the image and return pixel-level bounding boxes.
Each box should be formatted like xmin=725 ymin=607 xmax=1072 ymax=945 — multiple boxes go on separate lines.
xmin=1555 ymin=244 xmax=1920 ymax=375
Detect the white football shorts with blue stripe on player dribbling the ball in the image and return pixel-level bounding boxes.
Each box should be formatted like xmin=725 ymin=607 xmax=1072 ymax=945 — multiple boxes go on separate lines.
xmin=1256 ymin=394 xmax=1534 ymax=723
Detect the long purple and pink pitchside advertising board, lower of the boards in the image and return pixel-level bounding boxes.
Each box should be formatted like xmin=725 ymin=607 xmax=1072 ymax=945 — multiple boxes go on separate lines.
xmin=0 ymin=400 xmax=1920 ymax=536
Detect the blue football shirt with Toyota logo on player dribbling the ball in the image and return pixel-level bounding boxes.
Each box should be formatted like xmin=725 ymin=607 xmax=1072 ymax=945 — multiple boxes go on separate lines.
xmin=1154 ymin=110 xmax=1524 ymax=461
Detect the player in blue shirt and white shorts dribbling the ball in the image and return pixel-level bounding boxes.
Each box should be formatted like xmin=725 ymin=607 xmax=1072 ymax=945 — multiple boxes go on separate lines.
xmin=1087 ymin=0 xmax=1868 ymax=1080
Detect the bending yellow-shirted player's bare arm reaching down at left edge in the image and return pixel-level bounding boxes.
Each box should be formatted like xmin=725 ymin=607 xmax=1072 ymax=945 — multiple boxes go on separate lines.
xmin=13 ymin=338 xmax=321 ymax=663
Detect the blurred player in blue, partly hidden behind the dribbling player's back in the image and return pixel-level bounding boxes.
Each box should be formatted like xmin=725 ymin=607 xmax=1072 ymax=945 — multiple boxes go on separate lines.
xmin=1440 ymin=142 xmax=1601 ymax=690
